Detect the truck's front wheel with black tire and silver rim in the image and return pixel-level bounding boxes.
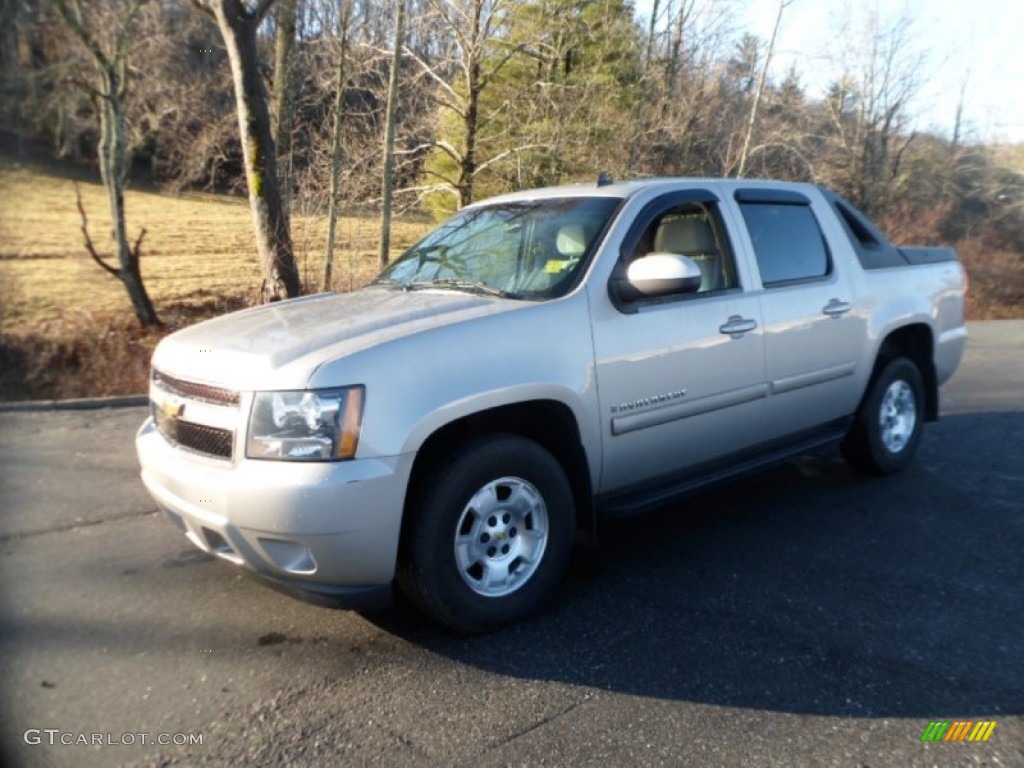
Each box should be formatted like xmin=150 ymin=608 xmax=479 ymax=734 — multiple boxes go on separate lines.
xmin=397 ymin=434 xmax=575 ymax=634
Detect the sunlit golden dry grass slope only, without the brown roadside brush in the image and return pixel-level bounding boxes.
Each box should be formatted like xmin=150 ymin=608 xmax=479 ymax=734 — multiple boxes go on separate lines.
xmin=0 ymin=159 xmax=426 ymax=332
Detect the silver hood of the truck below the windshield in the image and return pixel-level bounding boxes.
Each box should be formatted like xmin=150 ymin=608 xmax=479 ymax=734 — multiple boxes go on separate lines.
xmin=153 ymin=288 xmax=524 ymax=390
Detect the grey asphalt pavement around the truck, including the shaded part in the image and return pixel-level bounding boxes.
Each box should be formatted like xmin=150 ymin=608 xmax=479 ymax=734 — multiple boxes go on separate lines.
xmin=0 ymin=322 xmax=1024 ymax=768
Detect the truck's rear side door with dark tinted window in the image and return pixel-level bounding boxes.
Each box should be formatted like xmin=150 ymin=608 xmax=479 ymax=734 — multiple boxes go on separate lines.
xmin=734 ymin=187 xmax=866 ymax=440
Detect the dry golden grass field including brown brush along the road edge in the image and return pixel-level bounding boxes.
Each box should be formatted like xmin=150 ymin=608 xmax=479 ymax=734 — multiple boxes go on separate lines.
xmin=0 ymin=156 xmax=429 ymax=399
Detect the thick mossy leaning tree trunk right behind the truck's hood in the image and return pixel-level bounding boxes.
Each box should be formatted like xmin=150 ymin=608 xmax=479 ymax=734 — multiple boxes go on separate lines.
xmin=213 ymin=0 xmax=301 ymax=303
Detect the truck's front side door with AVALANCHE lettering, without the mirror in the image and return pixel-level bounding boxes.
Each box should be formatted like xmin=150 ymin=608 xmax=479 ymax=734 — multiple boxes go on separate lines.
xmin=591 ymin=189 xmax=767 ymax=494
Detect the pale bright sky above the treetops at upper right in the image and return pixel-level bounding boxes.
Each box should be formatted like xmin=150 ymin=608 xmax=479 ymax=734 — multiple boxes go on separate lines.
xmin=637 ymin=0 xmax=1024 ymax=143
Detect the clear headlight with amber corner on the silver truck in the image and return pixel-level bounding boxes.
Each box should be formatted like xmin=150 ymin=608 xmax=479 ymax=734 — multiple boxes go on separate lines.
xmin=246 ymin=386 xmax=365 ymax=461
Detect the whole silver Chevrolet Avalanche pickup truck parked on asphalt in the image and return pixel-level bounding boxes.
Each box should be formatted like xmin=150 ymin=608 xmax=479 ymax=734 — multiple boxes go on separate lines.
xmin=136 ymin=179 xmax=967 ymax=632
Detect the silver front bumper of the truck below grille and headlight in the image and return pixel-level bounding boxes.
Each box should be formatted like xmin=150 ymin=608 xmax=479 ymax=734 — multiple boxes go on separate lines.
xmin=135 ymin=419 xmax=414 ymax=607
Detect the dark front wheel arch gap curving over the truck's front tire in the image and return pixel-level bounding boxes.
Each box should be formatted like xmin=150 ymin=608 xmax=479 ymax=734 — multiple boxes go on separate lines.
xmin=401 ymin=399 xmax=596 ymax=544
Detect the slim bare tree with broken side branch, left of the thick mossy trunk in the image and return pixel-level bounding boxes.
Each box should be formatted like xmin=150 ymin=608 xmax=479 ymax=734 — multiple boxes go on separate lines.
xmin=53 ymin=0 xmax=160 ymax=327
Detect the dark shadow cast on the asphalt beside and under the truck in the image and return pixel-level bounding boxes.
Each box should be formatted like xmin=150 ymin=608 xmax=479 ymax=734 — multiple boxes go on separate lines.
xmin=367 ymin=413 xmax=1024 ymax=718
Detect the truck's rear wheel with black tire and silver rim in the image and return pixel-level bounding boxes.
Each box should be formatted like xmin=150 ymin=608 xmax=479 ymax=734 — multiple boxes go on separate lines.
xmin=842 ymin=357 xmax=925 ymax=475
